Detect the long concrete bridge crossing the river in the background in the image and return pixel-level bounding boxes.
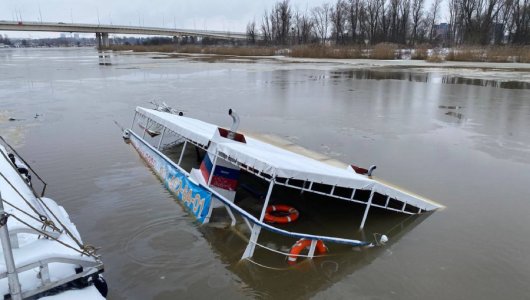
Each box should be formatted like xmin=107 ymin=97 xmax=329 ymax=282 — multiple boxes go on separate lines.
xmin=0 ymin=21 xmax=247 ymax=48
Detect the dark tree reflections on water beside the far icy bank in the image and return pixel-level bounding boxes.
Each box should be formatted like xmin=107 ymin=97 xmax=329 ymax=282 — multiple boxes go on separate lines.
xmin=331 ymin=69 xmax=530 ymax=89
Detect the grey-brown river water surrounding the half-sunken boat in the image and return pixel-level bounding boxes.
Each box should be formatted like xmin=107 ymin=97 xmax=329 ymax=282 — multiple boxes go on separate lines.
xmin=0 ymin=49 xmax=530 ymax=299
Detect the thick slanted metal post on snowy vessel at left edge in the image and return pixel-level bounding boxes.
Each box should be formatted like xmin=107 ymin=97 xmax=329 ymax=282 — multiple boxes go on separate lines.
xmin=0 ymin=194 xmax=22 ymax=300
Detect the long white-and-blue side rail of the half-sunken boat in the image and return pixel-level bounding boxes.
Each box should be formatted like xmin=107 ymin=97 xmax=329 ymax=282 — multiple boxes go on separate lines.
xmin=126 ymin=129 xmax=371 ymax=247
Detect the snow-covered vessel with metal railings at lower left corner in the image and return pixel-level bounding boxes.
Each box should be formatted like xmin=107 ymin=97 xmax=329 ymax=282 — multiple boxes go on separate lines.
xmin=0 ymin=137 xmax=107 ymax=300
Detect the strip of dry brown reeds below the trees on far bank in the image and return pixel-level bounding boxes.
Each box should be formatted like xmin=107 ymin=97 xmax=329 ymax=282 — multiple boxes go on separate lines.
xmin=109 ymin=43 xmax=530 ymax=63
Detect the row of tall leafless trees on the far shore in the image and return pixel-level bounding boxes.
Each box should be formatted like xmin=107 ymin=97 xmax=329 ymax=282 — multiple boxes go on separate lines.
xmin=246 ymin=0 xmax=530 ymax=47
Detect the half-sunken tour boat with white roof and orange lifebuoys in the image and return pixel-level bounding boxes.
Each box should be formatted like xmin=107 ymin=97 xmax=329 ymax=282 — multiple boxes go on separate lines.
xmin=124 ymin=106 xmax=441 ymax=262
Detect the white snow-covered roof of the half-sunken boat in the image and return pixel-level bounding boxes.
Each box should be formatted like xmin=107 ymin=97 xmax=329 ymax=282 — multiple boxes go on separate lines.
xmin=136 ymin=107 xmax=441 ymax=211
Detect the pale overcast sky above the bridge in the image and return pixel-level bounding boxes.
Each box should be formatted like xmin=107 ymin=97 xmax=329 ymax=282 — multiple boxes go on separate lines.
xmin=0 ymin=0 xmax=444 ymax=38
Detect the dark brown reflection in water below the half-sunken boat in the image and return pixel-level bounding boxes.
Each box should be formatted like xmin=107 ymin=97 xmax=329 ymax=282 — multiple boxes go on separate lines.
xmin=203 ymin=214 xmax=429 ymax=299
